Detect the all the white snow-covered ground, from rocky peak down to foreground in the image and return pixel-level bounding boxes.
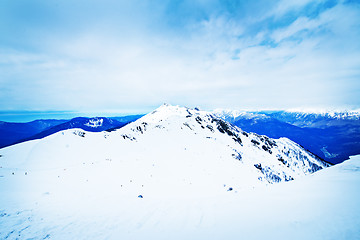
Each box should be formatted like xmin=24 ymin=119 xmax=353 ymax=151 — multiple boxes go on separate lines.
xmin=0 ymin=106 xmax=360 ymax=239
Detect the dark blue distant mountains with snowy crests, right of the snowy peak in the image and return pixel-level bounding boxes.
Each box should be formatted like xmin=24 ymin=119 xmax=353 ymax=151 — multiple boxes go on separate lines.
xmin=214 ymin=110 xmax=360 ymax=164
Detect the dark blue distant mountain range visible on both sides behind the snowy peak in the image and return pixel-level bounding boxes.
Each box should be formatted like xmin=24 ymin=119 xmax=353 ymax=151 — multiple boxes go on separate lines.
xmin=0 ymin=110 xmax=360 ymax=164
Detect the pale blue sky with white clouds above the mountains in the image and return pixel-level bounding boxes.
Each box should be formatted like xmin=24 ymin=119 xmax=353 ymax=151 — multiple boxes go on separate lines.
xmin=0 ymin=0 xmax=360 ymax=118
